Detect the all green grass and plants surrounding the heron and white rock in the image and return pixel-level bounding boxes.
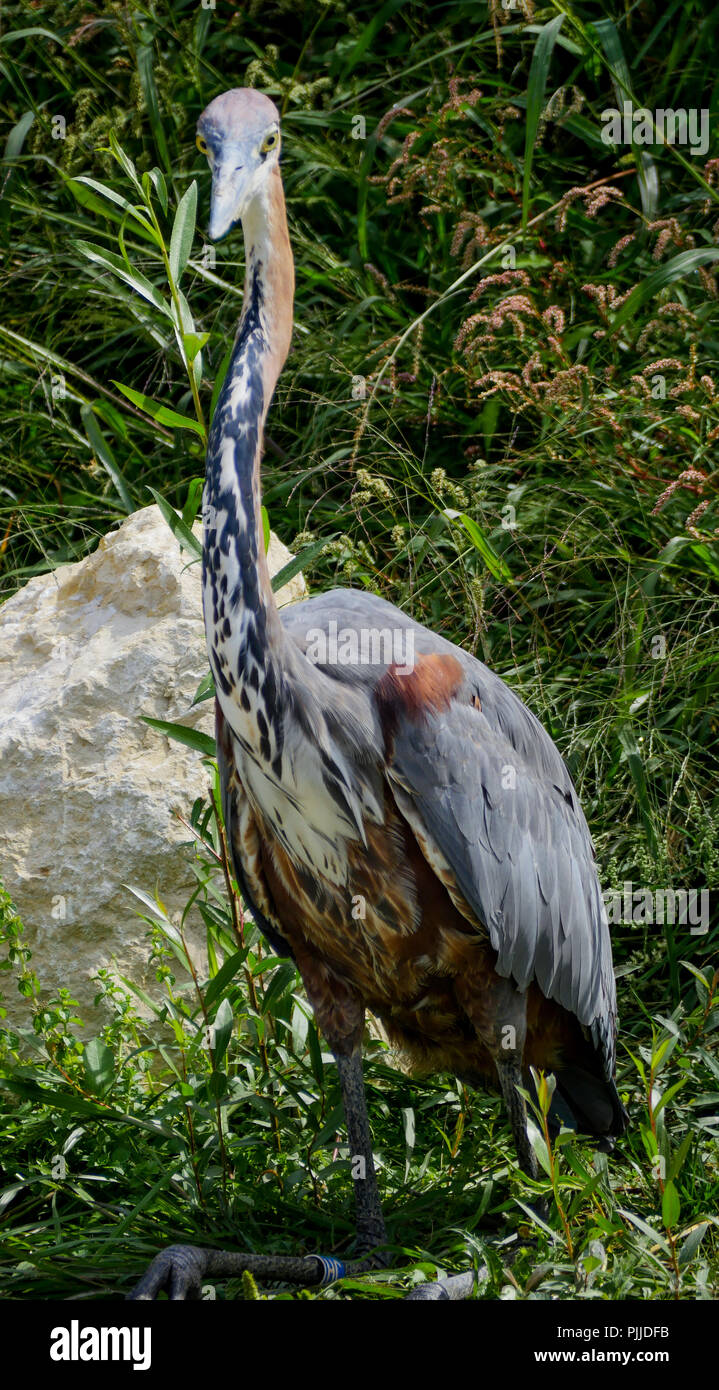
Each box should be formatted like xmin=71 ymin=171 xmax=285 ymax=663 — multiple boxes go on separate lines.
xmin=0 ymin=0 xmax=719 ymax=1298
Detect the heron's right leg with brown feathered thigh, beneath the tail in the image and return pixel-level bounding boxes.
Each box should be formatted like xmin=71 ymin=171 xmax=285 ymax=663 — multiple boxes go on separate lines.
xmin=455 ymin=969 xmax=537 ymax=1177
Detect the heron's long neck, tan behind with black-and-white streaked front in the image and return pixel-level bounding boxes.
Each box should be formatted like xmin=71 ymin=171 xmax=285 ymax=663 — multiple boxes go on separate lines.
xmin=203 ymin=171 xmax=295 ymax=713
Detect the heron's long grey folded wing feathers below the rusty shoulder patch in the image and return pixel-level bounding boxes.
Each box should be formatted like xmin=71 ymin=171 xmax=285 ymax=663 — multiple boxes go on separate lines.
xmin=391 ymin=699 xmax=616 ymax=1074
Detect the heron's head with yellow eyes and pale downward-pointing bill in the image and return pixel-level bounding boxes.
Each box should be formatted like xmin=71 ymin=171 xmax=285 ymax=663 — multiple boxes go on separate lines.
xmin=197 ymin=88 xmax=280 ymax=242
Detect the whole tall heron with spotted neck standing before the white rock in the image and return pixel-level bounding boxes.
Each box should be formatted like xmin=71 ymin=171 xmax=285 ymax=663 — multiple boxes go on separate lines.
xmin=131 ymin=88 xmax=627 ymax=1300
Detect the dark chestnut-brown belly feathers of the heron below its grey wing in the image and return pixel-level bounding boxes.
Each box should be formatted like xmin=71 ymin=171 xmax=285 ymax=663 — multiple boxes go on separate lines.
xmin=244 ymin=795 xmax=581 ymax=1077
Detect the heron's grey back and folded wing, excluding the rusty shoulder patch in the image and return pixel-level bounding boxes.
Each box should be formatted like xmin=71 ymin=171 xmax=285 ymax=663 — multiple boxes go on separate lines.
xmin=281 ymin=589 xmax=616 ymax=1077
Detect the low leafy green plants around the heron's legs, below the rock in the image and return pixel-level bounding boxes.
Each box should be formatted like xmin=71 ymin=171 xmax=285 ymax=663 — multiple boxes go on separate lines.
xmin=0 ymin=856 xmax=719 ymax=1298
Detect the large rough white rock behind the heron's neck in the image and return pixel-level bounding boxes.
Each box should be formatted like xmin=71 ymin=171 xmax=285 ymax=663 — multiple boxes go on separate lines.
xmin=0 ymin=506 xmax=306 ymax=1024
